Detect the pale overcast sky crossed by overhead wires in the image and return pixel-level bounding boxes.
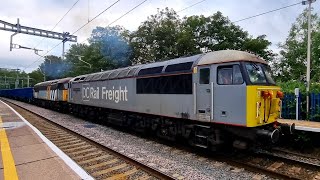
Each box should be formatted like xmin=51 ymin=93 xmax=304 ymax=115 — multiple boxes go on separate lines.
xmin=0 ymin=0 xmax=320 ymax=72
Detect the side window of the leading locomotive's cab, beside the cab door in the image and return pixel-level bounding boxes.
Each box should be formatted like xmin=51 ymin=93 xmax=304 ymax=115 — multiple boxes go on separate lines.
xmin=217 ymin=65 xmax=243 ymax=85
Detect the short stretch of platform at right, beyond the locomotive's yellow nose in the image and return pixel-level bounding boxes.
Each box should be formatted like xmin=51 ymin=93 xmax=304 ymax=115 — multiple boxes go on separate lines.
xmin=278 ymin=119 xmax=320 ymax=132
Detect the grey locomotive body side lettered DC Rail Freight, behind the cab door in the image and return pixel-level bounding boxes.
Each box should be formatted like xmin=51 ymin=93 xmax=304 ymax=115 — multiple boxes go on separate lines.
xmin=69 ymin=55 xmax=200 ymax=120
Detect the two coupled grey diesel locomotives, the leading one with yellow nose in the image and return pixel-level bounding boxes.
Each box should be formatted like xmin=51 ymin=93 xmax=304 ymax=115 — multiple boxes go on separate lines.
xmin=0 ymin=50 xmax=294 ymax=149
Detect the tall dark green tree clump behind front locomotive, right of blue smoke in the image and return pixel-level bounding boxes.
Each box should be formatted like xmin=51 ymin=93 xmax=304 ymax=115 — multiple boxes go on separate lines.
xmin=131 ymin=8 xmax=274 ymax=64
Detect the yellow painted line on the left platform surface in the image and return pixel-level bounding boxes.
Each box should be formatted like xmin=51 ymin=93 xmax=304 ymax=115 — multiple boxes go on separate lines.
xmin=0 ymin=116 xmax=18 ymax=180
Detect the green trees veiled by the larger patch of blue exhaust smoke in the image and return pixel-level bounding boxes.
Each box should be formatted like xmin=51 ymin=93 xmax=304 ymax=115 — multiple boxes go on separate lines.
xmin=66 ymin=26 xmax=131 ymax=77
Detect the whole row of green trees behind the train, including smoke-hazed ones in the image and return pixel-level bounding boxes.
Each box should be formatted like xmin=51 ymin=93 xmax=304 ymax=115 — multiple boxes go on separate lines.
xmin=30 ymin=8 xmax=274 ymax=80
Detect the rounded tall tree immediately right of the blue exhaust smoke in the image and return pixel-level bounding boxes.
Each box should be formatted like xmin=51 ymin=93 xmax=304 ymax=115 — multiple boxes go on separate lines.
xmin=130 ymin=8 xmax=181 ymax=64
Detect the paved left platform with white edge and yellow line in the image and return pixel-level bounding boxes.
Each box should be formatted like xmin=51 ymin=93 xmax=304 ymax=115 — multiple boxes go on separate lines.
xmin=0 ymin=100 xmax=93 ymax=180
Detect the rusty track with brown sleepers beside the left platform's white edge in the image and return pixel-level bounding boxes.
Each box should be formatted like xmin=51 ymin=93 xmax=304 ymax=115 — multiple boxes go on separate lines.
xmin=6 ymin=101 xmax=174 ymax=180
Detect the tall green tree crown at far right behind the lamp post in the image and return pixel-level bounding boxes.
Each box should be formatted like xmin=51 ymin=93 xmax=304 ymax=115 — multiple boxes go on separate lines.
xmin=274 ymin=9 xmax=320 ymax=82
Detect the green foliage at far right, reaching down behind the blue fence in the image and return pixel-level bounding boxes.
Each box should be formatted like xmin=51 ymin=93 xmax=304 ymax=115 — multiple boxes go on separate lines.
xmin=273 ymin=9 xmax=320 ymax=121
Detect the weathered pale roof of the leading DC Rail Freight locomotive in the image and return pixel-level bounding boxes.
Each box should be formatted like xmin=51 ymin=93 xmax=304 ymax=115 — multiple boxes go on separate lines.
xmin=70 ymin=50 xmax=266 ymax=81
